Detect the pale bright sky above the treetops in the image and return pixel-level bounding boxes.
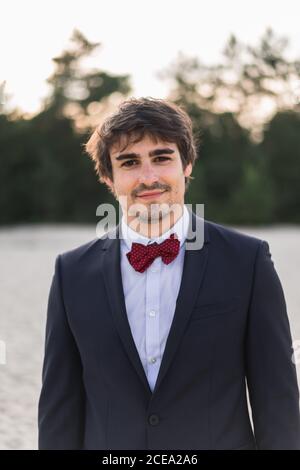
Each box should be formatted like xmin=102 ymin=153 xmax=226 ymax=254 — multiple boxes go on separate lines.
xmin=0 ymin=0 xmax=300 ymax=112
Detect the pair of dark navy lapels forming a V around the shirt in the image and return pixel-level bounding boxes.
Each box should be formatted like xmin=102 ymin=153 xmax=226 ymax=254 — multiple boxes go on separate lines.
xmin=101 ymin=209 xmax=209 ymax=396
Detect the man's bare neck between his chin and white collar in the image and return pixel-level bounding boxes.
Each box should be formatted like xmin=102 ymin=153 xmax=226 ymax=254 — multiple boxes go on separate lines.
xmin=124 ymin=204 xmax=183 ymax=238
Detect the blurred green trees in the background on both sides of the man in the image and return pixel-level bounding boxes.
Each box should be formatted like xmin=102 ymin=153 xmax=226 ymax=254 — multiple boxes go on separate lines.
xmin=0 ymin=30 xmax=300 ymax=224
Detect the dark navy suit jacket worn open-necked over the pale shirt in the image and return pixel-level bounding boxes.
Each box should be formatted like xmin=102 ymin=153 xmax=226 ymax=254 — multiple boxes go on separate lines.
xmin=38 ymin=212 xmax=300 ymax=450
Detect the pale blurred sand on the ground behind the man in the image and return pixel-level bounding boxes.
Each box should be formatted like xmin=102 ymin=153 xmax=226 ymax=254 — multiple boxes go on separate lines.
xmin=0 ymin=225 xmax=300 ymax=449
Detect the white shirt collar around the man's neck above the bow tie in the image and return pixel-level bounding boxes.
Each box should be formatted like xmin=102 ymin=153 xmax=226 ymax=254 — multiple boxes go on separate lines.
xmin=121 ymin=205 xmax=190 ymax=250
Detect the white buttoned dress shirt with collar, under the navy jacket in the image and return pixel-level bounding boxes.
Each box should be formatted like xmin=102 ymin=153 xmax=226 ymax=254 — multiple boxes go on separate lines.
xmin=120 ymin=205 xmax=190 ymax=391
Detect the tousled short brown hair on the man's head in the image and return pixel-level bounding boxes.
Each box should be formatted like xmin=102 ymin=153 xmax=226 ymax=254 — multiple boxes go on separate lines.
xmin=84 ymin=98 xmax=198 ymax=189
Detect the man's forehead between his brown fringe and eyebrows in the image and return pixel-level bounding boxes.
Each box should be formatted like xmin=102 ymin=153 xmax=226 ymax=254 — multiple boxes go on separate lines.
xmin=110 ymin=135 xmax=178 ymax=157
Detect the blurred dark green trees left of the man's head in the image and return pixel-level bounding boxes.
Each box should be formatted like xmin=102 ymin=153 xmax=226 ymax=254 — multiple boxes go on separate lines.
xmin=0 ymin=31 xmax=130 ymax=224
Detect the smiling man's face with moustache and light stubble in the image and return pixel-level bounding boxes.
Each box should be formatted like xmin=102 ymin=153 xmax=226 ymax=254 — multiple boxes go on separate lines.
xmin=104 ymin=136 xmax=192 ymax=229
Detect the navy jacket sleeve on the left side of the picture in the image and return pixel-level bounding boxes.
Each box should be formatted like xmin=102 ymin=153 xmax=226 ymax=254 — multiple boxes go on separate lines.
xmin=38 ymin=255 xmax=84 ymax=449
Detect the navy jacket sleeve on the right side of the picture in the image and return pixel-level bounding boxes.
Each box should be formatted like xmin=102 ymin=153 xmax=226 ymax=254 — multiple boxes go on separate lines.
xmin=246 ymin=241 xmax=300 ymax=449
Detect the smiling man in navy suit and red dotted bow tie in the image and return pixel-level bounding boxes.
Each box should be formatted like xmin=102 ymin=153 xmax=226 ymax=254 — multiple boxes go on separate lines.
xmin=39 ymin=98 xmax=300 ymax=450
